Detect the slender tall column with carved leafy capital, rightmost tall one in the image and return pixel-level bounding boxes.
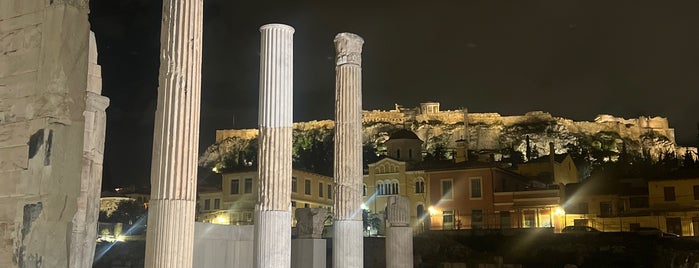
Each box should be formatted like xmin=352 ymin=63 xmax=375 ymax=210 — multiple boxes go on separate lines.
xmin=333 ymin=33 xmax=364 ymax=268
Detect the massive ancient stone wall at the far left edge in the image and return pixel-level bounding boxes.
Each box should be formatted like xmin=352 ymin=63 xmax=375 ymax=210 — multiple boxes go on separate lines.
xmin=0 ymin=0 xmax=109 ymax=267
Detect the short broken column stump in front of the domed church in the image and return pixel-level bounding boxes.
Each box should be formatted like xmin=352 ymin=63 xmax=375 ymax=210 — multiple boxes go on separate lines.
xmin=386 ymin=196 xmax=413 ymax=268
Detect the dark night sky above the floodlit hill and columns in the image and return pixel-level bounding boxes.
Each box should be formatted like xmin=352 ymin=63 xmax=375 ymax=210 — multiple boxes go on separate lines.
xmin=90 ymin=0 xmax=699 ymax=188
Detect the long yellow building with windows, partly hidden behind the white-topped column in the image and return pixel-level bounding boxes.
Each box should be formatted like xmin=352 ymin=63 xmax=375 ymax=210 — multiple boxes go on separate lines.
xmin=197 ymin=169 xmax=333 ymax=226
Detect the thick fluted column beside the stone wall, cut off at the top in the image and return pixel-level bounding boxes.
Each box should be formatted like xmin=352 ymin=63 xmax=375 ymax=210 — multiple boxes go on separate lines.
xmin=145 ymin=0 xmax=203 ymax=268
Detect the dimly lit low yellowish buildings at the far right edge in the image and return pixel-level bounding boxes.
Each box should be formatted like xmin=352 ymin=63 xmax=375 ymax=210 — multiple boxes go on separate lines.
xmin=564 ymin=178 xmax=699 ymax=236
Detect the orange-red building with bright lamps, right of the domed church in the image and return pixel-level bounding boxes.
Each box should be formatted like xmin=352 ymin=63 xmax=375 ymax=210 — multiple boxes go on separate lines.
xmin=427 ymin=167 xmax=563 ymax=231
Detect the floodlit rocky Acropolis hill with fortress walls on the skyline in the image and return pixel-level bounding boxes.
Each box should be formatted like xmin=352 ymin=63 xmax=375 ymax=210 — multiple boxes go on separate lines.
xmin=211 ymin=102 xmax=696 ymax=164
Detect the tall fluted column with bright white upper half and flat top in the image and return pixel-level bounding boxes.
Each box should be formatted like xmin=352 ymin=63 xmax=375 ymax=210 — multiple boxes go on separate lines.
xmin=253 ymin=24 xmax=294 ymax=267
